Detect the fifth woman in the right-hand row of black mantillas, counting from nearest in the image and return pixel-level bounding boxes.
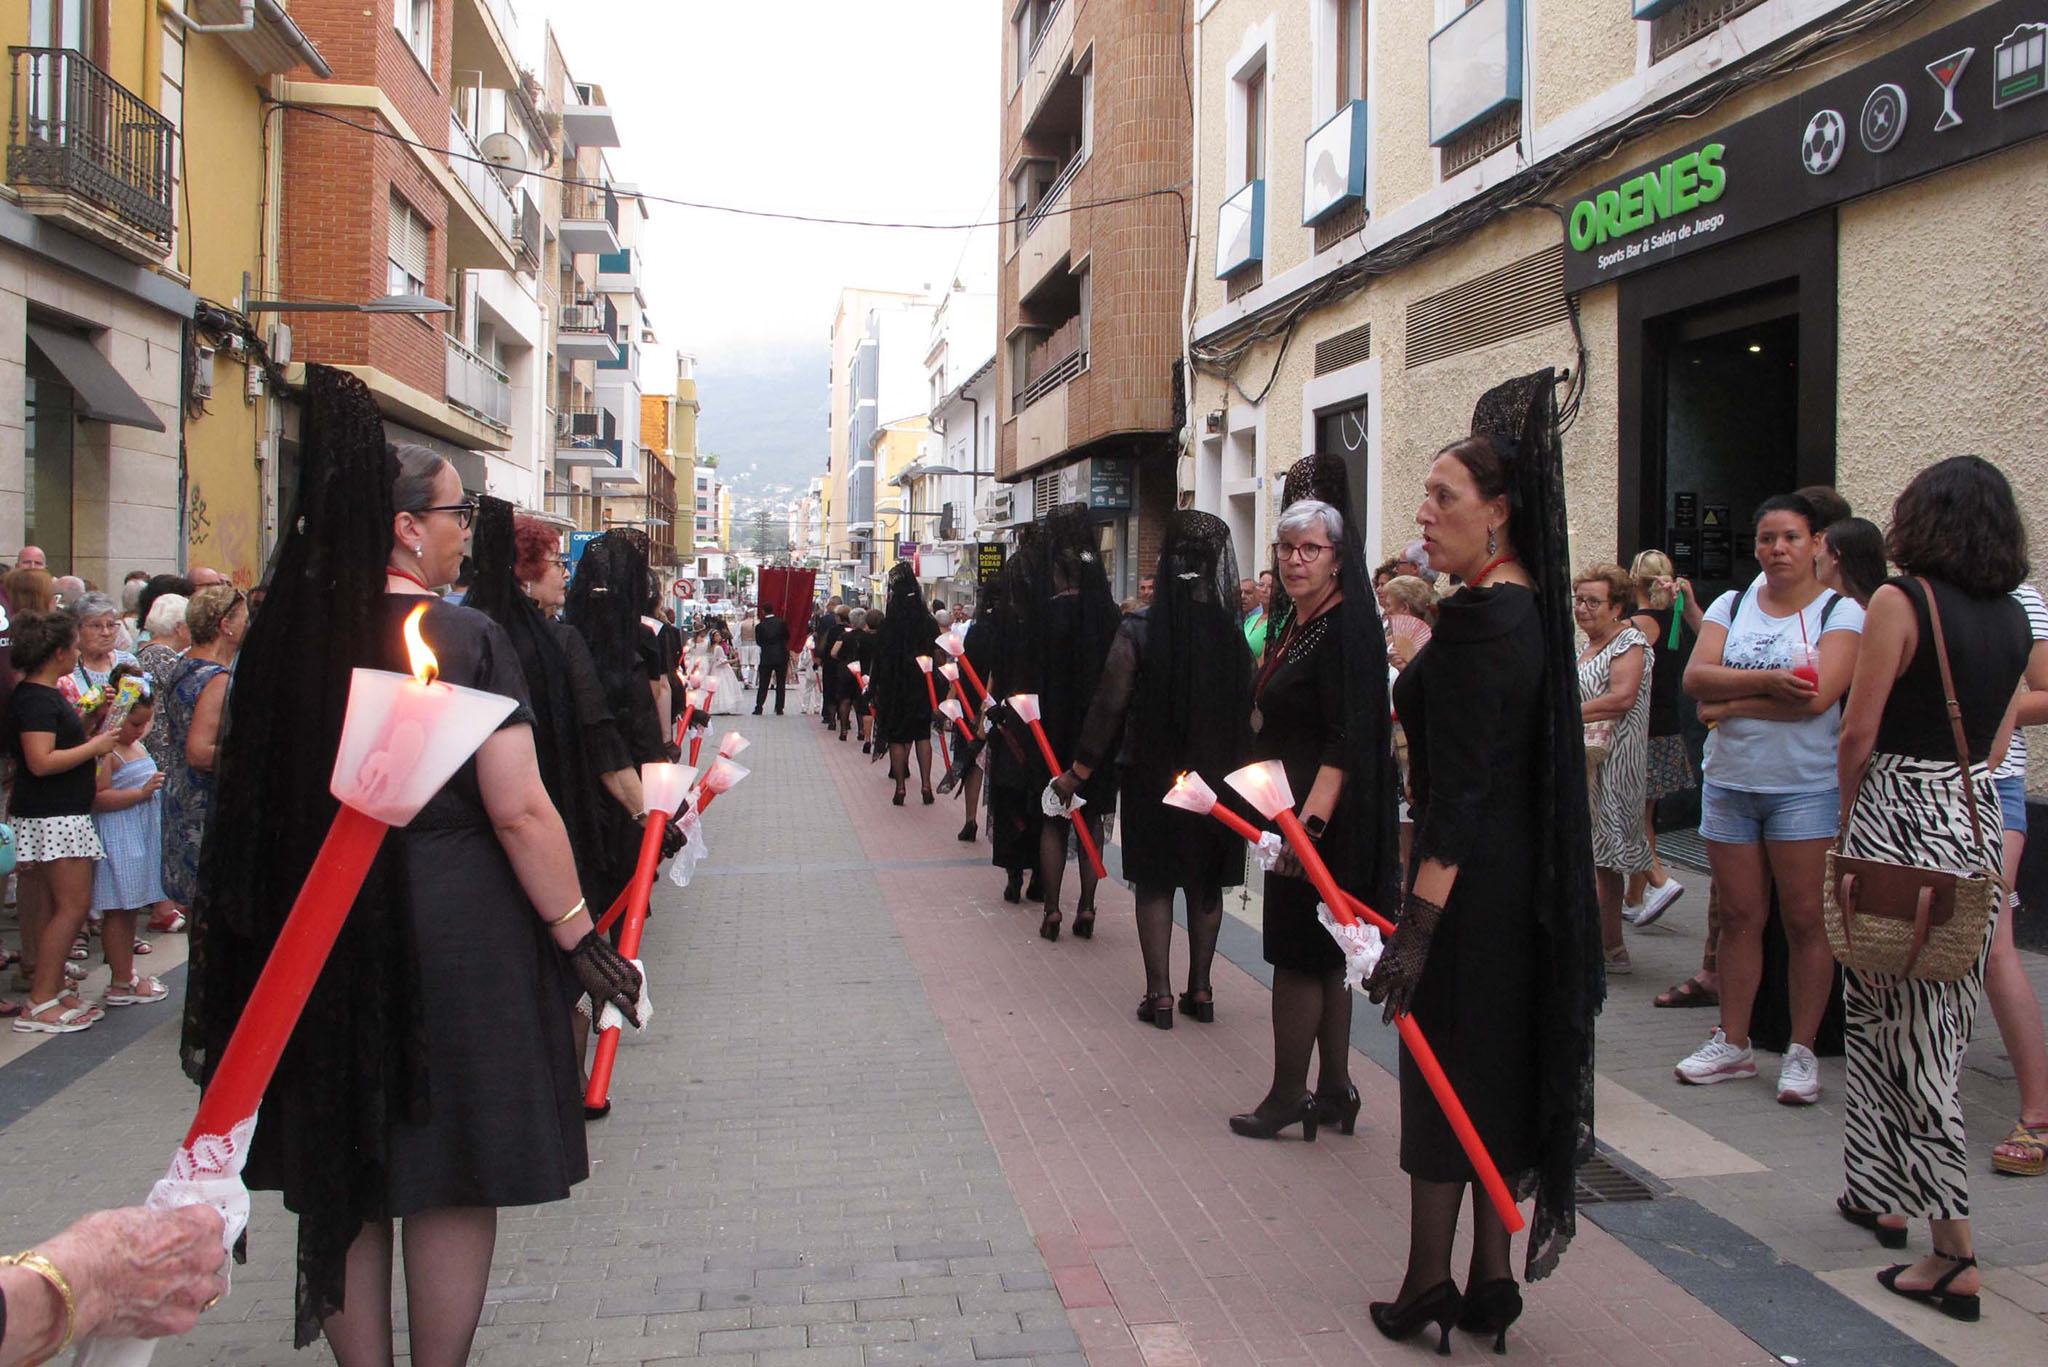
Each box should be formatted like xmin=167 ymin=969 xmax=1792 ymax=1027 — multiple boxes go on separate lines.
xmin=967 ymin=523 xmax=1044 ymax=902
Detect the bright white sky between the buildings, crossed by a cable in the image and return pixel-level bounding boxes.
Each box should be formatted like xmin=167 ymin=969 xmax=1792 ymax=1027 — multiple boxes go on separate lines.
xmin=520 ymin=0 xmax=1001 ymax=368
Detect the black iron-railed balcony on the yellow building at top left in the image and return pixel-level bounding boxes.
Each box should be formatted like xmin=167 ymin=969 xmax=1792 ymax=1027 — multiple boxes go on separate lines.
xmin=6 ymin=47 xmax=176 ymax=264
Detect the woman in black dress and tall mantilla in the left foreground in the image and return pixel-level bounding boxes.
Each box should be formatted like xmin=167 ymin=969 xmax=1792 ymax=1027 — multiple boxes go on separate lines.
xmin=180 ymin=367 xmax=639 ymax=1367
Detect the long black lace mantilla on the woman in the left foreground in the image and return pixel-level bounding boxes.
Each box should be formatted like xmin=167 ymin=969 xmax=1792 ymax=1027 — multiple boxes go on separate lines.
xmin=178 ymin=365 xmax=428 ymax=1347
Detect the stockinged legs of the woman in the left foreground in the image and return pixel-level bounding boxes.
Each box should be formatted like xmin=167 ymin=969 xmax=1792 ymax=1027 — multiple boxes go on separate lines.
xmin=322 ymin=1205 xmax=498 ymax=1367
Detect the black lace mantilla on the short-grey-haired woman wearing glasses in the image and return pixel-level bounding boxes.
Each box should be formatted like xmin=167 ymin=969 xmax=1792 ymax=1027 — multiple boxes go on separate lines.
xmin=1269 ymin=455 xmax=1401 ymax=916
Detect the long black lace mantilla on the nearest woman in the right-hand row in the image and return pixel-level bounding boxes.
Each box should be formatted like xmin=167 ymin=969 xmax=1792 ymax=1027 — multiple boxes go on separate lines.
xmin=1473 ymin=369 xmax=1606 ymax=1281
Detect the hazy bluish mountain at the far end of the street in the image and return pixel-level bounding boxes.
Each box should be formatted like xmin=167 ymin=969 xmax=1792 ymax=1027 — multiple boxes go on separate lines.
xmin=696 ymin=338 xmax=831 ymax=504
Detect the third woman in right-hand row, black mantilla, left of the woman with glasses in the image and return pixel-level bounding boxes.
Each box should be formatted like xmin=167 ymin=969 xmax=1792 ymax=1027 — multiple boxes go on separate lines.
xmin=1053 ymin=510 xmax=1251 ymax=1031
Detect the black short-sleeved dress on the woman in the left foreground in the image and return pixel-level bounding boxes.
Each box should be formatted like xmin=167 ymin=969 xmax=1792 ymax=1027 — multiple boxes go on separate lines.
xmin=248 ymin=594 xmax=590 ymax=1224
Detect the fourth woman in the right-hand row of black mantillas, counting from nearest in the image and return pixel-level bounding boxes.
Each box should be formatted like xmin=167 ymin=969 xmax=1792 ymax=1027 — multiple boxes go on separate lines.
xmin=1019 ymin=502 xmax=1122 ymax=941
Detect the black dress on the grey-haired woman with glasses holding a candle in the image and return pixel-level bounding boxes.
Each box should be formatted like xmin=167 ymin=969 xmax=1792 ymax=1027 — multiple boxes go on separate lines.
xmin=1251 ymin=611 xmax=1359 ymax=974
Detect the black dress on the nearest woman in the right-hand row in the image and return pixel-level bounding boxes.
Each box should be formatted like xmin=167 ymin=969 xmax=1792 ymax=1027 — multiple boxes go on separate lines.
xmin=1400 ymin=584 xmax=1546 ymax=1183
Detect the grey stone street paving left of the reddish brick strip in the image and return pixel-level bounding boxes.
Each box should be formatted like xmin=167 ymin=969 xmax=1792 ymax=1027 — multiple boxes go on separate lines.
xmin=0 ymin=713 xmax=1083 ymax=1367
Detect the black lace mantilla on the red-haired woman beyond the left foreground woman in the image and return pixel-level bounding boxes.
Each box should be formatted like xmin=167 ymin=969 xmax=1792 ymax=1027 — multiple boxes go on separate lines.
xmin=463 ymin=494 xmax=633 ymax=914
